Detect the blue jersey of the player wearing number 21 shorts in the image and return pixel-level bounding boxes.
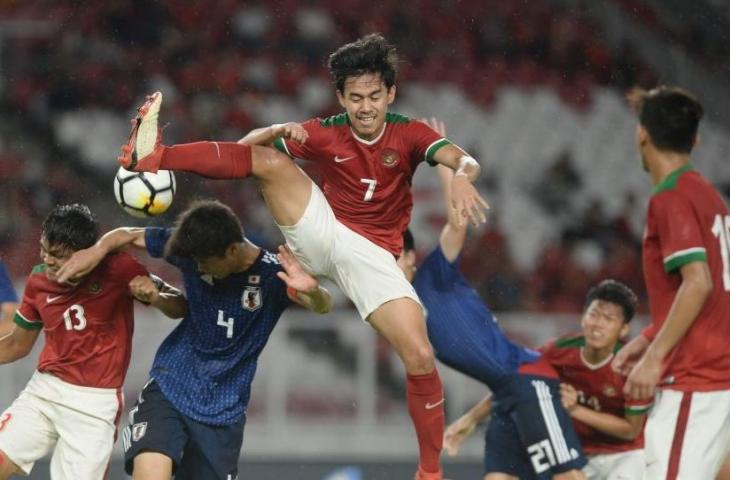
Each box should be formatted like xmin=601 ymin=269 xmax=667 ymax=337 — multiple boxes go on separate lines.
xmin=413 ymin=247 xmax=540 ymax=390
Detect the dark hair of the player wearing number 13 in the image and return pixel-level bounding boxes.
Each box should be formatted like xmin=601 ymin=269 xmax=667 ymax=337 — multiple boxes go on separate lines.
xmin=41 ymin=203 xmax=99 ymax=251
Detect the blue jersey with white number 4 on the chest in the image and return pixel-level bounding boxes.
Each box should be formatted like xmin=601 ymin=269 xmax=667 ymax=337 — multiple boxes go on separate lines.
xmin=145 ymin=228 xmax=292 ymax=425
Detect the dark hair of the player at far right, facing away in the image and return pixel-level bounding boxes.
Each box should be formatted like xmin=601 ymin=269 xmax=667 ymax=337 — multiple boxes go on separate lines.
xmin=628 ymin=85 xmax=704 ymax=153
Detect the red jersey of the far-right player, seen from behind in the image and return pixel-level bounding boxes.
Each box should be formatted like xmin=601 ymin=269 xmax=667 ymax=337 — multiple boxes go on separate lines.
xmin=642 ymin=165 xmax=730 ymax=391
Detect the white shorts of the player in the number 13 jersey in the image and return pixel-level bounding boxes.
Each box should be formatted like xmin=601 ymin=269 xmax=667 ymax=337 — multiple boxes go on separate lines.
xmin=0 ymin=372 xmax=123 ymax=480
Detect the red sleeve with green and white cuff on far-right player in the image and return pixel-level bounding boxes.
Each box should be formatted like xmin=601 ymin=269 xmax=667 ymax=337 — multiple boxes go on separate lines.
xmin=650 ymin=192 xmax=707 ymax=273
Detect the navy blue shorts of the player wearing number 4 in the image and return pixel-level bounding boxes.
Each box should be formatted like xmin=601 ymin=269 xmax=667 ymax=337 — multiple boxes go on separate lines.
xmin=122 ymin=381 xmax=245 ymax=480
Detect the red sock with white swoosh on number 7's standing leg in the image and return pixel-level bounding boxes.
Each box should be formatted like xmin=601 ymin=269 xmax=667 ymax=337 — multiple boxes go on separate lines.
xmin=406 ymin=368 xmax=444 ymax=473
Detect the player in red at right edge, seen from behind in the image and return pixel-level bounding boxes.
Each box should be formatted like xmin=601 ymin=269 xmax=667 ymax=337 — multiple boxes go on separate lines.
xmin=614 ymin=86 xmax=730 ymax=479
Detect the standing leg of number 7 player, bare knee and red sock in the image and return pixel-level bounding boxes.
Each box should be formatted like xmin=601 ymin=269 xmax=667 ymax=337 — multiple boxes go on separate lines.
xmin=368 ymin=298 xmax=444 ymax=480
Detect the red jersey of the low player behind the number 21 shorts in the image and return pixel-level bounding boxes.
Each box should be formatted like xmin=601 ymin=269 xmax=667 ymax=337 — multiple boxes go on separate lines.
xmin=539 ymin=334 xmax=652 ymax=455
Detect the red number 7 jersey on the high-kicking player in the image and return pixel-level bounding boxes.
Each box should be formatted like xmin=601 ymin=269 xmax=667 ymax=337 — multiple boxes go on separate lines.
xmin=274 ymin=113 xmax=450 ymax=256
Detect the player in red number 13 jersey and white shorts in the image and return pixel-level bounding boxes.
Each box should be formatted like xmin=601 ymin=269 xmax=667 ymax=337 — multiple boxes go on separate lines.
xmin=0 ymin=204 xmax=187 ymax=480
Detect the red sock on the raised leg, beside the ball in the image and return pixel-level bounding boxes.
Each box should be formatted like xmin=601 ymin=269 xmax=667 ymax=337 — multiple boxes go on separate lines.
xmin=160 ymin=142 xmax=251 ymax=178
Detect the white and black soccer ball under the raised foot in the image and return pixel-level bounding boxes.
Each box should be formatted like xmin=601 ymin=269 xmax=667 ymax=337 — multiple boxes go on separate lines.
xmin=114 ymin=168 xmax=175 ymax=218
